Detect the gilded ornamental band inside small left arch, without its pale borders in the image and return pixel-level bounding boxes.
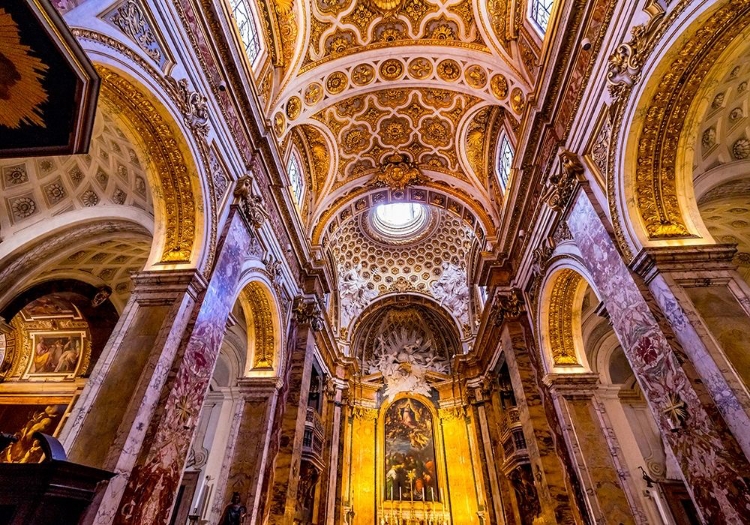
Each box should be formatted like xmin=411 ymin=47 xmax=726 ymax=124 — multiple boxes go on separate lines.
xmin=241 ymin=282 xmax=276 ymax=370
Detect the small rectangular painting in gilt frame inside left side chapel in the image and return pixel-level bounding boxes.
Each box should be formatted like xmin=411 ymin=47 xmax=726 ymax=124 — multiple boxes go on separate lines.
xmin=24 ymin=331 xmax=86 ymax=379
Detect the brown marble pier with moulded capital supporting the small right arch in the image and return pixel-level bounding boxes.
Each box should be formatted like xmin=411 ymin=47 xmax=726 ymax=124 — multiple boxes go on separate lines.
xmin=544 ymin=374 xmax=646 ymax=525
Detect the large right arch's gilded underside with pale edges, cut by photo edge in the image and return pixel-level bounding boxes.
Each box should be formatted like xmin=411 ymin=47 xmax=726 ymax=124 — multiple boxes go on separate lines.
xmin=620 ymin=1 xmax=750 ymax=251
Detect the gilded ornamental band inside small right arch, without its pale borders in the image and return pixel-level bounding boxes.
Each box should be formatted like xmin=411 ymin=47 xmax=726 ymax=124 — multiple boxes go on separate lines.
xmin=547 ymin=269 xmax=584 ymax=366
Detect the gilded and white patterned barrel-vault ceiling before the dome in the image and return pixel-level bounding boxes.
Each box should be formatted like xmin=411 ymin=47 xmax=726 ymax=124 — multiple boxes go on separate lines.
xmin=259 ymin=0 xmax=539 ymax=231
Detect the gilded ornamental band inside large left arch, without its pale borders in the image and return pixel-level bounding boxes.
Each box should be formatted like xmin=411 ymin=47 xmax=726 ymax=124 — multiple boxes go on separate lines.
xmin=97 ymin=66 xmax=202 ymax=263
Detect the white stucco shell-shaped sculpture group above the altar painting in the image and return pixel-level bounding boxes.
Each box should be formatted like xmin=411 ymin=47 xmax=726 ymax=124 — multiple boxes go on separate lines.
xmin=368 ymin=327 xmax=448 ymax=398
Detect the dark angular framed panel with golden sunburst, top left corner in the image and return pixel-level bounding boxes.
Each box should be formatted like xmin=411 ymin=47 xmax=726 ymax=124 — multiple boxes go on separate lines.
xmin=0 ymin=0 xmax=99 ymax=157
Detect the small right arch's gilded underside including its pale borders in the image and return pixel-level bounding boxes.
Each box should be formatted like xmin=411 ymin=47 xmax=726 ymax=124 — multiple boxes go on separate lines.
xmin=539 ymin=260 xmax=598 ymax=374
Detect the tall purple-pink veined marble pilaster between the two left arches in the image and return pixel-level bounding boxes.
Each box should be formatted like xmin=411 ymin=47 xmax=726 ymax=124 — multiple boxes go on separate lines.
xmin=113 ymin=210 xmax=251 ymax=524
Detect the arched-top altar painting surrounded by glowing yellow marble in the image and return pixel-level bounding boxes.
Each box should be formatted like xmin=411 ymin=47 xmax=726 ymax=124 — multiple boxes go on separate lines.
xmin=384 ymin=398 xmax=440 ymax=501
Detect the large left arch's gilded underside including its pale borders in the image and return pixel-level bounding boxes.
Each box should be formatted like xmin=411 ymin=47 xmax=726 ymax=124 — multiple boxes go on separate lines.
xmin=96 ymin=65 xmax=206 ymax=269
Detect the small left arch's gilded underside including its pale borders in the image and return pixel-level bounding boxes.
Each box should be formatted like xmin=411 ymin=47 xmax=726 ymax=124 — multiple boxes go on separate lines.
xmin=238 ymin=280 xmax=283 ymax=377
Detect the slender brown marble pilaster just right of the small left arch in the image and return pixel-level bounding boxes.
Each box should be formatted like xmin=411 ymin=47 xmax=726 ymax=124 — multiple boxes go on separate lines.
xmin=266 ymin=319 xmax=315 ymax=525
